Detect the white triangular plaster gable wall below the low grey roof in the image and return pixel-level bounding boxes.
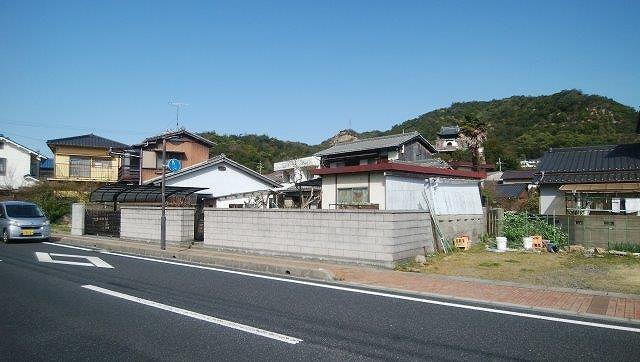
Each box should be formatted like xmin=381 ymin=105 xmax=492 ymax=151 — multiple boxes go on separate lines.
xmin=162 ymin=162 xmax=273 ymax=197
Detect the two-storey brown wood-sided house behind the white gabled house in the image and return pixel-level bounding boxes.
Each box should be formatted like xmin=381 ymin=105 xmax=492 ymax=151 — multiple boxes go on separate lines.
xmin=127 ymin=129 xmax=215 ymax=185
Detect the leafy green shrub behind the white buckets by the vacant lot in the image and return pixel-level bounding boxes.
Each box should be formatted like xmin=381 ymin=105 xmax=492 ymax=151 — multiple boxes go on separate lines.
xmin=502 ymin=212 xmax=569 ymax=247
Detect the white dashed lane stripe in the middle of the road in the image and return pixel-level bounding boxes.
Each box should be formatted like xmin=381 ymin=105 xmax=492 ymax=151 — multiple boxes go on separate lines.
xmin=82 ymin=285 xmax=302 ymax=344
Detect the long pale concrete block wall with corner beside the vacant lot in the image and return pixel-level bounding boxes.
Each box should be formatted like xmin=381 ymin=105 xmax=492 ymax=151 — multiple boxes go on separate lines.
xmin=204 ymin=208 xmax=434 ymax=267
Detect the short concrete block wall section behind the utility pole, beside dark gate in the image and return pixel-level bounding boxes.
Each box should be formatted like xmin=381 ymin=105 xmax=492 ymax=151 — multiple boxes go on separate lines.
xmin=120 ymin=206 xmax=195 ymax=242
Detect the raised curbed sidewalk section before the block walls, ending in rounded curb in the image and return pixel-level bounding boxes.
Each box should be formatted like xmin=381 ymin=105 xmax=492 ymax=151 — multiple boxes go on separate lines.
xmin=57 ymin=235 xmax=335 ymax=281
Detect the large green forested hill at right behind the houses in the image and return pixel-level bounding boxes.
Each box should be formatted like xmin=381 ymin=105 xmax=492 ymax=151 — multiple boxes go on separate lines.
xmin=385 ymin=90 xmax=640 ymax=167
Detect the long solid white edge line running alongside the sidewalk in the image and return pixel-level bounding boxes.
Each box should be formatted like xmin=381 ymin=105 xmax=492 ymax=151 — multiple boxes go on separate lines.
xmin=101 ymin=251 xmax=640 ymax=333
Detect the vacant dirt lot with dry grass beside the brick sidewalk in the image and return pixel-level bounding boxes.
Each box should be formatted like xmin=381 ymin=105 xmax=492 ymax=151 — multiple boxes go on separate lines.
xmin=398 ymin=245 xmax=640 ymax=295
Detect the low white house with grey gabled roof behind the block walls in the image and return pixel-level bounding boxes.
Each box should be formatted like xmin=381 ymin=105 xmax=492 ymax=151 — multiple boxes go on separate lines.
xmin=144 ymin=155 xmax=282 ymax=208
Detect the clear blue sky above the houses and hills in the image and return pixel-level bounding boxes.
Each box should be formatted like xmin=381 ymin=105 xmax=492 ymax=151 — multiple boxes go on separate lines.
xmin=0 ymin=0 xmax=640 ymax=153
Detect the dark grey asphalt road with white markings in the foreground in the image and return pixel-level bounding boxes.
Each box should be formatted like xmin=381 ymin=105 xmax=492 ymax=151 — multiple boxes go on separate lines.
xmin=0 ymin=239 xmax=640 ymax=361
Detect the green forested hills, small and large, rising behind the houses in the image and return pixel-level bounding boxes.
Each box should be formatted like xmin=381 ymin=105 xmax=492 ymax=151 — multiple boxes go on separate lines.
xmin=202 ymin=90 xmax=640 ymax=173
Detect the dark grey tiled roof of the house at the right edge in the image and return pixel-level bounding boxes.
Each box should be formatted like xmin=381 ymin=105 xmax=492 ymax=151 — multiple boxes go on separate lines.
xmin=535 ymin=143 xmax=640 ymax=184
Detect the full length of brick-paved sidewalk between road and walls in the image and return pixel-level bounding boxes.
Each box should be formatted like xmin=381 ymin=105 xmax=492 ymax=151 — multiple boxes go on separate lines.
xmin=55 ymin=236 xmax=640 ymax=321
